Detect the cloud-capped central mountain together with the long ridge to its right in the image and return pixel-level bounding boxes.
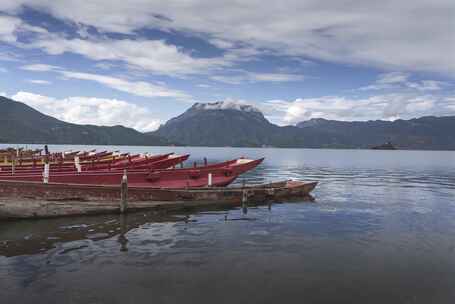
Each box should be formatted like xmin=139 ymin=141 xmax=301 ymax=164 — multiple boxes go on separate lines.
xmin=151 ymin=101 xmax=455 ymax=150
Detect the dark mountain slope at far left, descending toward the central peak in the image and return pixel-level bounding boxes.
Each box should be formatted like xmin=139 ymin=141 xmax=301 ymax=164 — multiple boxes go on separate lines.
xmin=0 ymin=96 xmax=168 ymax=145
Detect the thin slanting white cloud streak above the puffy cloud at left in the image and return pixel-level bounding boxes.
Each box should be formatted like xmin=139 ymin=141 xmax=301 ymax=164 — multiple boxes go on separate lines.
xmin=60 ymin=71 xmax=189 ymax=99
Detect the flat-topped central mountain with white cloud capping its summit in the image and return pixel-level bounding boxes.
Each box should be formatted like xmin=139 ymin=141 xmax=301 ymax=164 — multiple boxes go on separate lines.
xmin=153 ymin=101 xmax=306 ymax=147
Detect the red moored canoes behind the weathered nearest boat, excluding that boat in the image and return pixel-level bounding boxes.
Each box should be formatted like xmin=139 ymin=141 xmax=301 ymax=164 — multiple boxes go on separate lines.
xmin=0 ymin=151 xmax=263 ymax=189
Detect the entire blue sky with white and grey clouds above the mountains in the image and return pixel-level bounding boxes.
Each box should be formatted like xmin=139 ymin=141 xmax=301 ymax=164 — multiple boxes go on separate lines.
xmin=0 ymin=0 xmax=455 ymax=131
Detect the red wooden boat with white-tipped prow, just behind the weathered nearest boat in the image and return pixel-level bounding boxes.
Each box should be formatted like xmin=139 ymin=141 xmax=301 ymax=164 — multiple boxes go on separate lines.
xmin=0 ymin=158 xmax=263 ymax=189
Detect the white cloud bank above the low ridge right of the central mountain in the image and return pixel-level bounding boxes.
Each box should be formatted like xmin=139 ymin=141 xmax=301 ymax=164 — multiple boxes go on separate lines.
xmin=265 ymin=93 xmax=455 ymax=125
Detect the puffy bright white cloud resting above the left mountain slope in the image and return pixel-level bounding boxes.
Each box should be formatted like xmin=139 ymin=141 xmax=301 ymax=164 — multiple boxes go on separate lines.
xmin=12 ymin=92 xmax=161 ymax=132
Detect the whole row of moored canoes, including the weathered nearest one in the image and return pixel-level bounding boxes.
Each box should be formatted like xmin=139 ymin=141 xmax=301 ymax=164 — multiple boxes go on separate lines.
xmin=0 ymin=148 xmax=317 ymax=218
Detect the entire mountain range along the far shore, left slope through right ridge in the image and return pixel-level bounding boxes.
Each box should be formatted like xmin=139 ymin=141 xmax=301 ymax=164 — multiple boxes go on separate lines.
xmin=0 ymin=97 xmax=455 ymax=150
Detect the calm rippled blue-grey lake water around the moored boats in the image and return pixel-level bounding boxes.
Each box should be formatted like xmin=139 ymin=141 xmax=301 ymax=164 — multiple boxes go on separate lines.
xmin=0 ymin=146 xmax=455 ymax=304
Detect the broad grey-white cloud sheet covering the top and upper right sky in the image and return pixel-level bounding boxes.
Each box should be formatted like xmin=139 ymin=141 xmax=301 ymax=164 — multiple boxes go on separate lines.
xmin=0 ymin=0 xmax=455 ymax=75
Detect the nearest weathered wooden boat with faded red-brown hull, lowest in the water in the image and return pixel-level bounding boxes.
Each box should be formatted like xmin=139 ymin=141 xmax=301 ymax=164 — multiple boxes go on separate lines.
xmin=0 ymin=181 xmax=317 ymax=219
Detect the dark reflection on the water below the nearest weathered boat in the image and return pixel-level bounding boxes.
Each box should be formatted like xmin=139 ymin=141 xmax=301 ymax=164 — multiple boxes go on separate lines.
xmin=0 ymin=212 xmax=187 ymax=257
